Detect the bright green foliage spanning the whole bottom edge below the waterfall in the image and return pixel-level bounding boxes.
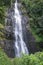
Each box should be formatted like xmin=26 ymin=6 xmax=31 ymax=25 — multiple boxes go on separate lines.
xmin=0 ymin=48 xmax=43 ymax=65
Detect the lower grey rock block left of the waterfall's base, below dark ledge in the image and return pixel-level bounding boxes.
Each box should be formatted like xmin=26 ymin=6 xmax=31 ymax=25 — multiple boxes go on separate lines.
xmin=0 ymin=40 xmax=15 ymax=58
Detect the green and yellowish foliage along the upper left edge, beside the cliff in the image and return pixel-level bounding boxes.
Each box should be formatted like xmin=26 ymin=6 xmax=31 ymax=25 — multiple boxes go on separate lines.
xmin=0 ymin=0 xmax=11 ymax=40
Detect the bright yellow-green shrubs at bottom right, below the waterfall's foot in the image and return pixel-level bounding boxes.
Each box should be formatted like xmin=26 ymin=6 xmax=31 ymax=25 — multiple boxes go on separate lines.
xmin=13 ymin=52 xmax=43 ymax=65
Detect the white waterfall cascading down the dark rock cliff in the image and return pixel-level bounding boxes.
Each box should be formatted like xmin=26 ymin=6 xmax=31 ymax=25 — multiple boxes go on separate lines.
xmin=14 ymin=0 xmax=28 ymax=57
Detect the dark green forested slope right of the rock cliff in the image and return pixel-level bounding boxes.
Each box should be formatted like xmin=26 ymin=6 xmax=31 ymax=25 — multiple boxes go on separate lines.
xmin=21 ymin=0 xmax=43 ymax=42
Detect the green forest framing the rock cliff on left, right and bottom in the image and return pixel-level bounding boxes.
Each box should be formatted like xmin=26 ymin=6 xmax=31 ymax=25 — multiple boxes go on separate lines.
xmin=0 ymin=0 xmax=43 ymax=65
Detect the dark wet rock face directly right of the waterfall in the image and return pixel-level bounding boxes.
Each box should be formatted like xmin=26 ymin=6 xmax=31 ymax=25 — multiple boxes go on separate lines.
xmin=22 ymin=15 xmax=36 ymax=53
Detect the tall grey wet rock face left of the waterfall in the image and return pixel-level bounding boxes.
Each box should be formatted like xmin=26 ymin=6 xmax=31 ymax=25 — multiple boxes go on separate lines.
xmin=0 ymin=5 xmax=15 ymax=58
